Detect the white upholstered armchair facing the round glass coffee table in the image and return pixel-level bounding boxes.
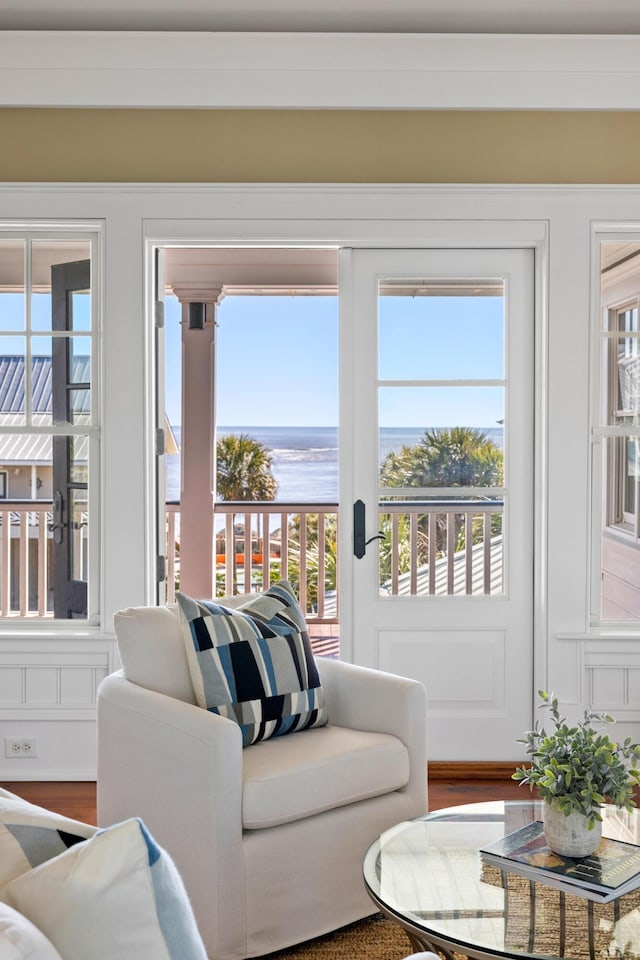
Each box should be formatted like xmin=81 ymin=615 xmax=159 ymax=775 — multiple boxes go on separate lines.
xmin=98 ymin=607 xmax=427 ymax=960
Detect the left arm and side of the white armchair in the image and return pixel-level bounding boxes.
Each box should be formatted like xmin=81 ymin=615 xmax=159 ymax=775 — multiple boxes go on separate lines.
xmin=97 ymin=671 xmax=245 ymax=950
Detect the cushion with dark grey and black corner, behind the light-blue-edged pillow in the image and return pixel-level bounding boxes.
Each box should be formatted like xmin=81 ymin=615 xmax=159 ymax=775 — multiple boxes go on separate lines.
xmin=0 ymin=790 xmax=97 ymax=886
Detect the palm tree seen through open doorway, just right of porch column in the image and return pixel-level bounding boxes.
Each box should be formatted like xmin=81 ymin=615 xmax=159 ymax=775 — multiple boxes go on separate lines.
xmin=216 ymin=433 xmax=278 ymax=501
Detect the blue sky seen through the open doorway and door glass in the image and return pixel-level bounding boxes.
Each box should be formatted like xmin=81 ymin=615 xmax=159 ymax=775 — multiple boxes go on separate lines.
xmin=165 ymin=296 xmax=504 ymax=428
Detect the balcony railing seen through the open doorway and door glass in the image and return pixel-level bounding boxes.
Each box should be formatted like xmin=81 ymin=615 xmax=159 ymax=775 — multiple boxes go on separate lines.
xmin=167 ymin=500 xmax=504 ymax=623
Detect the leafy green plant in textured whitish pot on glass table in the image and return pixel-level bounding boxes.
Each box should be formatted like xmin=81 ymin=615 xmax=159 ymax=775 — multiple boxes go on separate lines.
xmin=512 ymin=690 xmax=640 ymax=857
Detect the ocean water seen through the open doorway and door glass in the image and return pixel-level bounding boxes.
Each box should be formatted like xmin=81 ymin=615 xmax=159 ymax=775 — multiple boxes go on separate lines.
xmin=166 ymin=427 xmax=502 ymax=503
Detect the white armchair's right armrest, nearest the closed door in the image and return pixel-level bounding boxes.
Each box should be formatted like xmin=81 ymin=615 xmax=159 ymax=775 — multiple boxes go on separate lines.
xmin=316 ymin=657 xmax=427 ymax=816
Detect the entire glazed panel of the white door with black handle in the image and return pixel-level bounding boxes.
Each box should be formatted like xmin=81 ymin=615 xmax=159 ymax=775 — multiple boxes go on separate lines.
xmin=378 ymin=279 xmax=507 ymax=596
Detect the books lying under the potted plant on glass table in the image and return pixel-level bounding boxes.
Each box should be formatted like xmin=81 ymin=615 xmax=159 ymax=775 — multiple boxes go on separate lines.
xmin=480 ymin=820 xmax=640 ymax=903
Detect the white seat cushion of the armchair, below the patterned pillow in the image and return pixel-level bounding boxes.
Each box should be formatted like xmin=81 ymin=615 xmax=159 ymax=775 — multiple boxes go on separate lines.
xmin=242 ymin=724 xmax=409 ymax=830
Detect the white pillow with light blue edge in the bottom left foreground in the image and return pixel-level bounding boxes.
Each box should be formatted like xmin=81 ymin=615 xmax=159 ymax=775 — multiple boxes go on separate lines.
xmin=0 ymin=819 xmax=207 ymax=960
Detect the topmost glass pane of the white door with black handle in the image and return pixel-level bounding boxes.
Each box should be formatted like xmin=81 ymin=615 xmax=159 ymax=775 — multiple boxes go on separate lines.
xmin=378 ymin=283 xmax=504 ymax=380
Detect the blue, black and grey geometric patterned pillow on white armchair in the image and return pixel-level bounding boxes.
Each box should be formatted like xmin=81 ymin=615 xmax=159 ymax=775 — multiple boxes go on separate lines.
xmin=176 ymin=580 xmax=328 ymax=746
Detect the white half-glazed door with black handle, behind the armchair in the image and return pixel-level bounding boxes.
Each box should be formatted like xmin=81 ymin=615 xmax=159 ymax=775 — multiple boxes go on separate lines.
xmin=340 ymin=249 xmax=534 ymax=761
